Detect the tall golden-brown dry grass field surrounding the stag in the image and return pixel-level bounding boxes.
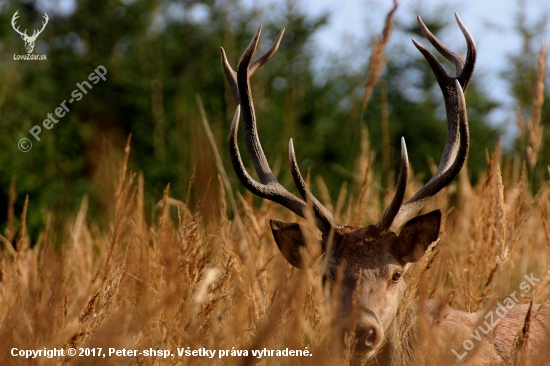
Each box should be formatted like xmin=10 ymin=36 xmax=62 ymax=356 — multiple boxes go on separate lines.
xmin=0 ymin=128 xmax=550 ymax=365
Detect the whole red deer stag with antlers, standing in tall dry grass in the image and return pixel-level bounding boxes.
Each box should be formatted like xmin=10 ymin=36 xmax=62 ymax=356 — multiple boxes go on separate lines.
xmin=221 ymin=14 xmax=550 ymax=366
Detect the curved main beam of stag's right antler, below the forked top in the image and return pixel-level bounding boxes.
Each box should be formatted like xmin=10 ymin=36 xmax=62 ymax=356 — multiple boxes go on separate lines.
xmin=390 ymin=80 xmax=470 ymax=231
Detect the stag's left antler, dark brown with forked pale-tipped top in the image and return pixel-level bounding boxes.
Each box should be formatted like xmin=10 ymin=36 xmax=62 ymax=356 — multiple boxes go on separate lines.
xmin=221 ymin=27 xmax=335 ymax=234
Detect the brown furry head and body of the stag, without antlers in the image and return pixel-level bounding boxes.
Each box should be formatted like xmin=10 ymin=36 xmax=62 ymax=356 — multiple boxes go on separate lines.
xmin=272 ymin=213 xmax=550 ymax=366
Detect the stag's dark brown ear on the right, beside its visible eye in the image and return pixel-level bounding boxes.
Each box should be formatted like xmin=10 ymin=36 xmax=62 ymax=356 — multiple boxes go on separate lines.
xmin=395 ymin=210 xmax=441 ymax=265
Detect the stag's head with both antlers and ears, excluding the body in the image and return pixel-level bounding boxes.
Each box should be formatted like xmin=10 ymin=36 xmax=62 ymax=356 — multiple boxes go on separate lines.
xmin=221 ymin=14 xmax=477 ymax=358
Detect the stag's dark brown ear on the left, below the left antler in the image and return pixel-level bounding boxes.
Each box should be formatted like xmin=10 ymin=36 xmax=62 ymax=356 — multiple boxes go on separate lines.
xmin=269 ymin=219 xmax=314 ymax=268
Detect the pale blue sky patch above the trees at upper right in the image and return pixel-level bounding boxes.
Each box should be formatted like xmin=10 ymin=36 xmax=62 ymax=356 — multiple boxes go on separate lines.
xmin=296 ymin=0 xmax=550 ymax=139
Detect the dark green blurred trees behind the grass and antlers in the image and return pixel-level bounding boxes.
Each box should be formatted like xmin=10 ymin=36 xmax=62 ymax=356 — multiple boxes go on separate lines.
xmin=0 ymin=0 xmax=549 ymax=237
